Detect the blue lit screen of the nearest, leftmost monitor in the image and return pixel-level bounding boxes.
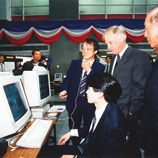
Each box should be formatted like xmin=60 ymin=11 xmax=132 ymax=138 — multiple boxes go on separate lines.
xmin=3 ymin=84 xmax=27 ymax=121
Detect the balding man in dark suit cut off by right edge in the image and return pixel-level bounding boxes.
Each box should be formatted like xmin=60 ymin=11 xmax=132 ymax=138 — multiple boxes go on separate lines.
xmin=139 ymin=6 xmax=158 ymax=158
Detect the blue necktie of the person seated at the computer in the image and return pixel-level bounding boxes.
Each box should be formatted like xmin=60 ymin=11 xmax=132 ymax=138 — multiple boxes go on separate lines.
xmin=77 ymin=117 xmax=96 ymax=153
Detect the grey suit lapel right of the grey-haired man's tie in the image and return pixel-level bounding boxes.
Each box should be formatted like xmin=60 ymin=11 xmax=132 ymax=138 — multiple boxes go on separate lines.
xmin=113 ymin=47 xmax=132 ymax=77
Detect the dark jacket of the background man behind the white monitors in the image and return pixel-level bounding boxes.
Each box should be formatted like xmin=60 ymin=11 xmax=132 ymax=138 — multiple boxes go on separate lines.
xmin=21 ymin=60 xmax=47 ymax=73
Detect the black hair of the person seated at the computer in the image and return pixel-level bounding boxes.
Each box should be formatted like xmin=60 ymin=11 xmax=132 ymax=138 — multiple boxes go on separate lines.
xmin=87 ymin=73 xmax=122 ymax=103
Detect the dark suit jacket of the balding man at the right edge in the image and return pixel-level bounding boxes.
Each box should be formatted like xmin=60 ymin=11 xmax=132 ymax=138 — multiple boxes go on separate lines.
xmin=139 ymin=60 xmax=158 ymax=152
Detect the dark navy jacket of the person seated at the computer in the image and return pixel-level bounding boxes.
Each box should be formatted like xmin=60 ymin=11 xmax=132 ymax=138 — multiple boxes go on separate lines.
xmin=78 ymin=103 xmax=125 ymax=158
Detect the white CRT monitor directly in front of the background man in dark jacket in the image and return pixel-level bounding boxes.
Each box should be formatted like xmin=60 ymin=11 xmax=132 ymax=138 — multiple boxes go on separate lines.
xmin=22 ymin=69 xmax=51 ymax=107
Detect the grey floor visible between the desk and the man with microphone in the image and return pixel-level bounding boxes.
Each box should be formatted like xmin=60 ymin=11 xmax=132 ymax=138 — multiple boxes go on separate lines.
xmin=49 ymin=95 xmax=69 ymax=145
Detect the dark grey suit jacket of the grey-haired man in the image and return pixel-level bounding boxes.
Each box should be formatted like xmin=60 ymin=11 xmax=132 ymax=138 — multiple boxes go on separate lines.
xmin=109 ymin=46 xmax=151 ymax=118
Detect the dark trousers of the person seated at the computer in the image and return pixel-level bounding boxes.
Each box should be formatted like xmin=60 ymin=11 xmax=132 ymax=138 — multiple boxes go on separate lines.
xmin=38 ymin=145 xmax=81 ymax=158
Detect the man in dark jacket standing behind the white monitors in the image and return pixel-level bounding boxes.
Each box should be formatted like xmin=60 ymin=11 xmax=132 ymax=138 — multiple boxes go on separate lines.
xmin=21 ymin=50 xmax=45 ymax=73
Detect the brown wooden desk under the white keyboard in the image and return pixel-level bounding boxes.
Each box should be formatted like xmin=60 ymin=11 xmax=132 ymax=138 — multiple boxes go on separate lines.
xmin=3 ymin=118 xmax=57 ymax=158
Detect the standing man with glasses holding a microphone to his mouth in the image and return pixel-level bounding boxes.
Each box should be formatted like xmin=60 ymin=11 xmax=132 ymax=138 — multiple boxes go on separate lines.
xmin=59 ymin=39 xmax=105 ymax=145
